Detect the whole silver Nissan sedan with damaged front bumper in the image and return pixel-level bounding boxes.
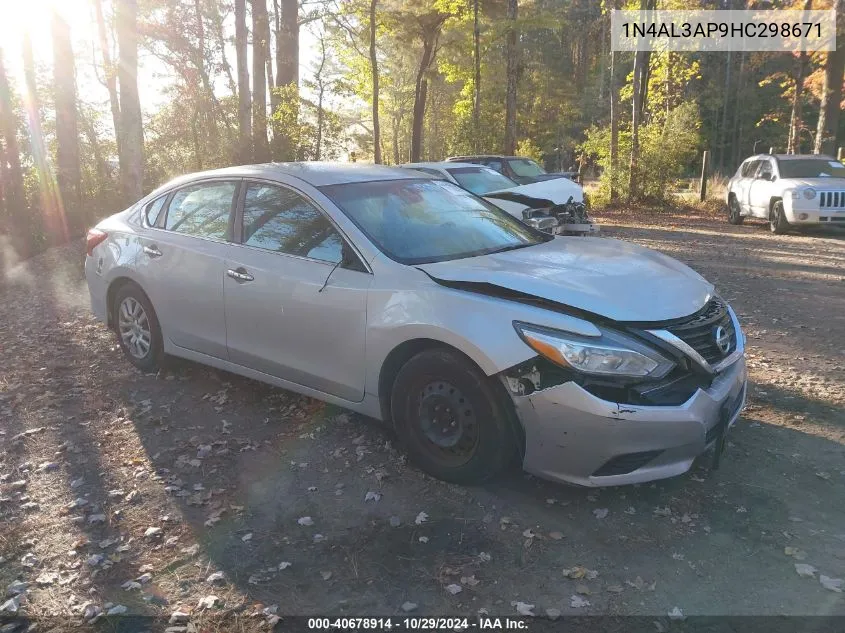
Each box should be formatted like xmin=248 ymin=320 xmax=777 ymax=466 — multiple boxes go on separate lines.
xmin=85 ymin=163 xmax=746 ymax=486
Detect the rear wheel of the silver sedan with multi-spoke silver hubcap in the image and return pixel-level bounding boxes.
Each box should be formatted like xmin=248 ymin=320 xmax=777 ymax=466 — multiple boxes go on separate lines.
xmin=112 ymin=283 xmax=164 ymax=372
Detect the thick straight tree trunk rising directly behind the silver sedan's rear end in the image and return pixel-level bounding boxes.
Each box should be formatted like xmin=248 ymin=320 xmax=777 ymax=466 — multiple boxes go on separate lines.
xmin=115 ymin=0 xmax=144 ymax=203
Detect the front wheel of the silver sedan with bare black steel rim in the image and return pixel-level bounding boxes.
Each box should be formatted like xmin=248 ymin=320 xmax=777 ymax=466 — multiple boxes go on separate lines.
xmin=390 ymin=348 xmax=518 ymax=484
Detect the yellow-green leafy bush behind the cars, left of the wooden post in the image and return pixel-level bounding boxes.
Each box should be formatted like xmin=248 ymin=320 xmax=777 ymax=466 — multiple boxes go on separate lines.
xmin=580 ymin=103 xmax=701 ymax=202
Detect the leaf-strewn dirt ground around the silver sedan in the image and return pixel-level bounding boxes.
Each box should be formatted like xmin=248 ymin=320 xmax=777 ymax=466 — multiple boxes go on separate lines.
xmin=0 ymin=211 xmax=845 ymax=630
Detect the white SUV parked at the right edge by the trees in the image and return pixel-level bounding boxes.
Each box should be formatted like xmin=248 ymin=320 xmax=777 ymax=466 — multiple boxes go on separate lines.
xmin=727 ymin=154 xmax=845 ymax=233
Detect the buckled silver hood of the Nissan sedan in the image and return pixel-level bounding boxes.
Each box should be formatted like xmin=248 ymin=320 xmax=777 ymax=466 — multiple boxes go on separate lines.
xmin=418 ymin=237 xmax=714 ymax=321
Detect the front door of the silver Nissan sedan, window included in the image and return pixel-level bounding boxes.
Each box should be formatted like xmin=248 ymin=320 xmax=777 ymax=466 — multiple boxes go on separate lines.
xmin=224 ymin=181 xmax=372 ymax=402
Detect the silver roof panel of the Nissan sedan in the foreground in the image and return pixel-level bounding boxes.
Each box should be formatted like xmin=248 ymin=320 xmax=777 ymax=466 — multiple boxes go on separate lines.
xmin=159 ymin=161 xmax=422 ymax=187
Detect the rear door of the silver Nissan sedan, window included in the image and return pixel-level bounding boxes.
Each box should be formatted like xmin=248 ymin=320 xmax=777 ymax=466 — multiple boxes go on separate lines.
xmin=137 ymin=179 xmax=239 ymax=359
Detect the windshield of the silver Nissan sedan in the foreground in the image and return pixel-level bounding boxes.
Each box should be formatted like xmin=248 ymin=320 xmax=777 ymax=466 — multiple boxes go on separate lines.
xmin=320 ymin=179 xmax=552 ymax=264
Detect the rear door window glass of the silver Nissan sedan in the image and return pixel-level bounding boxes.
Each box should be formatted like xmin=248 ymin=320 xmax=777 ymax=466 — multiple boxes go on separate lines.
xmin=164 ymin=182 xmax=236 ymax=240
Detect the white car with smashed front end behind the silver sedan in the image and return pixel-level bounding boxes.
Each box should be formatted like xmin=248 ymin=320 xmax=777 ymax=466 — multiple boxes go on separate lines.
xmin=400 ymin=161 xmax=599 ymax=235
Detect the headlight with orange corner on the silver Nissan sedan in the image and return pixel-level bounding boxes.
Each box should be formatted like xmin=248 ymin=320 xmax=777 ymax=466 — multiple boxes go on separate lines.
xmin=514 ymin=322 xmax=675 ymax=378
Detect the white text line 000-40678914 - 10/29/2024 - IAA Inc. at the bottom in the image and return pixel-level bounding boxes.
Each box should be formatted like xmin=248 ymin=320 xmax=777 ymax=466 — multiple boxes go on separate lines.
xmin=308 ymin=617 xmax=528 ymax=631
